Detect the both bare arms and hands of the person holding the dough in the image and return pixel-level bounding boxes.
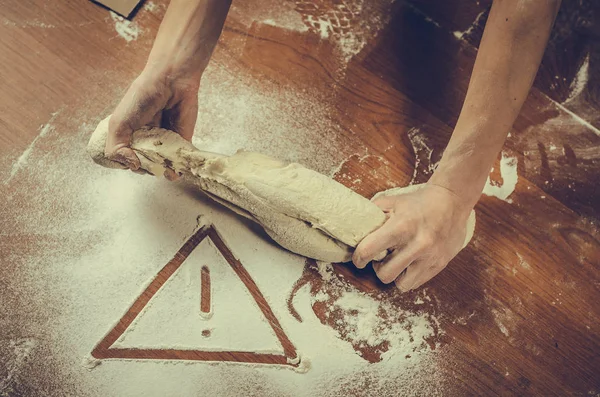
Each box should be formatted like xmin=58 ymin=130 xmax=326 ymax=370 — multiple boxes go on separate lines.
xmin=105 ymin=0 xmax=560 ymax=291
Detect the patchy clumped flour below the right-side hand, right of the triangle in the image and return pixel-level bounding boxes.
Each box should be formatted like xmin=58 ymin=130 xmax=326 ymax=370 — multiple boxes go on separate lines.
xmin=304 ymin=263 xmax=443 ymax=367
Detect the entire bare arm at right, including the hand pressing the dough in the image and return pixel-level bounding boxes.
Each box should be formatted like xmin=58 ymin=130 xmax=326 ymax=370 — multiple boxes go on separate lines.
xmin=353 ymin=0 xmax=560 ymax=291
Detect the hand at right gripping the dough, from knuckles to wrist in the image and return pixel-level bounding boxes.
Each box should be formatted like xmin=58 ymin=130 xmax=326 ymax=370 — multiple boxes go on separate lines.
xmin=352 ymin=184 xmax=472 ymax=292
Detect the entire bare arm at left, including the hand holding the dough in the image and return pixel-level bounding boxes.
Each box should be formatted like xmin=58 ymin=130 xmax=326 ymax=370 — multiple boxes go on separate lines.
xmin=105 ymin=0 xmax=231 ymax=172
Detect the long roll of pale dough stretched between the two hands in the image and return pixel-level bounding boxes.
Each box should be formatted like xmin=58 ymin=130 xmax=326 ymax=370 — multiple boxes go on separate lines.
xmin=88 ymin=116 xmax=474 ymax=262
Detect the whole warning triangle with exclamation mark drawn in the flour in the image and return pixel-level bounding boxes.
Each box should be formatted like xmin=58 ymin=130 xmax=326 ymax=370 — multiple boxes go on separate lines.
xmin=92 ymin=225 xmax=298 ymax=365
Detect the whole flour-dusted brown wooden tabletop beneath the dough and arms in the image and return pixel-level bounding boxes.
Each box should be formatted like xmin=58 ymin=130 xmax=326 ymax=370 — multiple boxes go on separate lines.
xmin=0 ymin=0 xmax=600 ymax=397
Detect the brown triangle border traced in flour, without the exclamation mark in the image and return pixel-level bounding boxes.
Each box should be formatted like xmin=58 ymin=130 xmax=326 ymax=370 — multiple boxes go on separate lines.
xmin=91 ymin=224 xmax=300 ymax=367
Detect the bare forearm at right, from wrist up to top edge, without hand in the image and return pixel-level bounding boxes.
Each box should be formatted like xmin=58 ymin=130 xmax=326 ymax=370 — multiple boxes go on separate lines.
xmin=430 ymin=0 xmax=560 ymax=205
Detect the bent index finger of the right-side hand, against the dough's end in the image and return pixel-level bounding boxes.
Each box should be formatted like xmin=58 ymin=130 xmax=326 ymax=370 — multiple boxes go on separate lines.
xmin=352 ymin=220 xmax=405 ymax=269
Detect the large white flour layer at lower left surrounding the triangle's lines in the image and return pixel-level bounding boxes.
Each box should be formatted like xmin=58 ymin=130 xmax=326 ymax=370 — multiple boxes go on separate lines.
xmin=0 ymin=110 xmax=446 ymax=396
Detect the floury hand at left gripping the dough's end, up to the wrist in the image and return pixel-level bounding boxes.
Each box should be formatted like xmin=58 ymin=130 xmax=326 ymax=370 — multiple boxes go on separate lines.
xmin=104 ymin=71 xmax=200 ymax=180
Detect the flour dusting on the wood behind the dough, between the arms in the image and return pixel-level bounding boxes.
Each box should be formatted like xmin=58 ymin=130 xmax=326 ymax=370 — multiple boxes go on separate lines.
xmin=193 ymin=62 xmax=363 ymax=175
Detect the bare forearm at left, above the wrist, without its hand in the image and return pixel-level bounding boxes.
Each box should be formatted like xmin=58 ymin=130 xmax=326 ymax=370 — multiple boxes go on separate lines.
xmin=146 ymin=0 xmax=231 ymax=78
